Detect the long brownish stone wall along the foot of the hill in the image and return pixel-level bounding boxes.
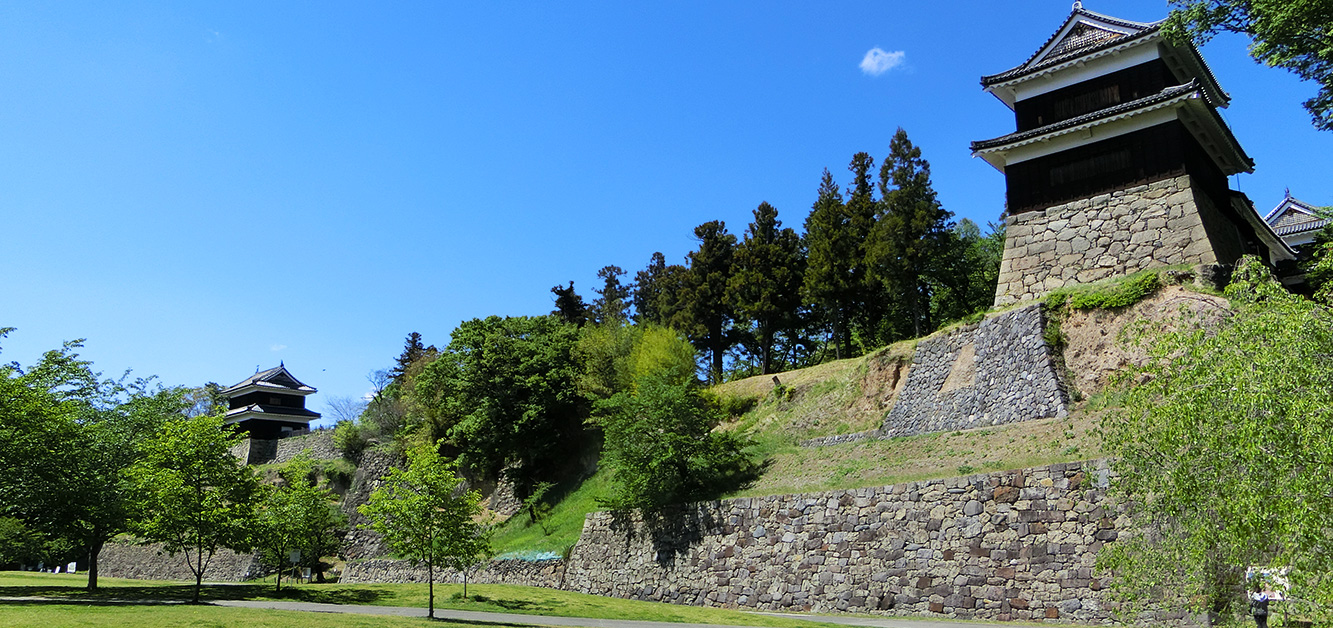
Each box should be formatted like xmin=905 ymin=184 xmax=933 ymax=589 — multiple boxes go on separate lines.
xmin=564 ymin=461 xmax=1172 ymax=621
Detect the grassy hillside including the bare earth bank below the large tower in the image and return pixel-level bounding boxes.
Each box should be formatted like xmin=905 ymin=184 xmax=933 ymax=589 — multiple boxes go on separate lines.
xmin=496 ymin=268 xmax=1226 ymax=555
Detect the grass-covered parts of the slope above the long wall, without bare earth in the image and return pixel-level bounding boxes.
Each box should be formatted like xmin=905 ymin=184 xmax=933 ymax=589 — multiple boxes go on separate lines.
xmin=496 ymin=272 xmax=1193 ymax=553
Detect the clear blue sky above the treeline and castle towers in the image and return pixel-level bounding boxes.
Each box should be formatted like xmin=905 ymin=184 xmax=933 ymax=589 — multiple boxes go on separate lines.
xmin=0 ymin=1 xmax=1333 ymax=426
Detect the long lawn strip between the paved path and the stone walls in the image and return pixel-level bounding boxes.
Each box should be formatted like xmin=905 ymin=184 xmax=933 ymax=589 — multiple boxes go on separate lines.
xmin=0 ymin=572 xmax=828 ymax=628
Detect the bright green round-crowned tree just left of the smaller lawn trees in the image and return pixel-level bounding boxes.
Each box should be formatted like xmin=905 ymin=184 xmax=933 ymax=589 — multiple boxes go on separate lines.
xmin=129 ymin=416 xmax=259 ymax=604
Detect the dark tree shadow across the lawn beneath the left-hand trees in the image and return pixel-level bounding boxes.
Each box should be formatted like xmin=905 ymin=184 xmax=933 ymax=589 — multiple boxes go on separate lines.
xmin=0 ymin=584 xmax=389 ymax=604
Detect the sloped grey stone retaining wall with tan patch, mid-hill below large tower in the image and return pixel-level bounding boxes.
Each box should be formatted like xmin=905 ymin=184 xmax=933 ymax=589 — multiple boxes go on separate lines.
xmin=880 ymin=304 xmax=1068 ymax=437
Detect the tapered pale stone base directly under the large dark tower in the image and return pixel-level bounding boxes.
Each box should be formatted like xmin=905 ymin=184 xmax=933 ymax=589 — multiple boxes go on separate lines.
xmin=994 ymin=175 xmax=1234 ymax=305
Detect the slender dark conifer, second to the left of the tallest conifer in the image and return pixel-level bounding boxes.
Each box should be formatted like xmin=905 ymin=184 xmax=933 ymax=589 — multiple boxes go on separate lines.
xmin=801 ymin=169 xmax=860 ymax=359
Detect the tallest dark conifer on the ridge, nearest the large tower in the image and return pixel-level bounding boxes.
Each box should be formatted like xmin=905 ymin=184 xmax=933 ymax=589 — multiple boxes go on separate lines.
xmin=866 ymin=128 xmax=953 ymax=337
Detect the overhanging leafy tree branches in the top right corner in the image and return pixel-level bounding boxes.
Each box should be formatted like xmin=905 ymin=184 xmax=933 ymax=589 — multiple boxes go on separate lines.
xmin=1164 ymin=0 xmax=1333 ymax=131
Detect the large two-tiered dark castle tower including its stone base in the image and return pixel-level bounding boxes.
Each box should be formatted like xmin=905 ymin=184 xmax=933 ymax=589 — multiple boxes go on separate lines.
xmin=972 ymin=3 xmax=1292 ymax=305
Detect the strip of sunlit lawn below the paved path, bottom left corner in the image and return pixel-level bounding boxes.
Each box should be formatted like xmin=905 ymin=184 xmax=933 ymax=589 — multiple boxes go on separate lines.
xmin=0 ymin=603 xmax=447 ymax=628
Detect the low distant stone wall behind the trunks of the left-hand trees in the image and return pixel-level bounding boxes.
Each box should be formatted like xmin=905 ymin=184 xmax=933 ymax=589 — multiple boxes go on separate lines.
xmin=97 ymin=543 xmax=265 ymax=583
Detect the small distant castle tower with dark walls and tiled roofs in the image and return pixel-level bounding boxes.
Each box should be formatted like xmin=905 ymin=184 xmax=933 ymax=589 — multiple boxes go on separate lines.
xmin=223 ymin=364 xmax=320 ymax=440
